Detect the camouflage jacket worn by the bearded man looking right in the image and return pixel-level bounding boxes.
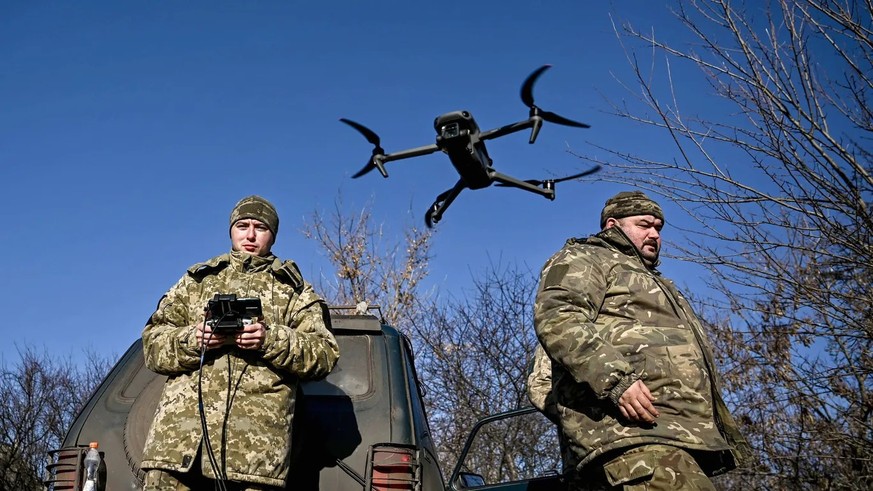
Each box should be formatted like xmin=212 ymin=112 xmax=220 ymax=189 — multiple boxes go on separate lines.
xmin=530 ymin=227 xmax=749 ymax=475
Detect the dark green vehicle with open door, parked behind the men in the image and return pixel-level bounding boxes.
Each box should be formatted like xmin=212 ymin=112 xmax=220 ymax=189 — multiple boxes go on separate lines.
xmin=45 ymin=309 xmax=564 ymax=491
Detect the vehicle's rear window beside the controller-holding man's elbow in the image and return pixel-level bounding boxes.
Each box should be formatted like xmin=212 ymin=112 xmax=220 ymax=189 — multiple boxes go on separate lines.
xmin=303 ymin=335 xmax=373 ymax=399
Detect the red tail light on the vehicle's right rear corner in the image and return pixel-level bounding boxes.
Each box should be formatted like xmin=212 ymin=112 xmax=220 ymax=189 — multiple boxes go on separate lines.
xmin=366 ymin=443 xmax=421 ymax=491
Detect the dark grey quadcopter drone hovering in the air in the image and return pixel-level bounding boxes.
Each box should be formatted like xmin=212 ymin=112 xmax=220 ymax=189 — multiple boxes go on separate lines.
xmin=340 ymin=65 xmax=600 ymax=228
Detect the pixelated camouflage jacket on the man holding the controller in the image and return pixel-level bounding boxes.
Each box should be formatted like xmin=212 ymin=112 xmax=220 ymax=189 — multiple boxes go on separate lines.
xmin=141 ymin=252 xmax=339 ymax=487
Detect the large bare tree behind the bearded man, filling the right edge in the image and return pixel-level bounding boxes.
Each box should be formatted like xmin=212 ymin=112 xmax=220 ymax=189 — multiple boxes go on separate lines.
xmin=582 ymin=0 xmax=873 ymax=489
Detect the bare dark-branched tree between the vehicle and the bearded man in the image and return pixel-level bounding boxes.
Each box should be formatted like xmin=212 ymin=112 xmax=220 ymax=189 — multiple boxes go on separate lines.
xmin=414 ymin=263 xmax=560 ymax=483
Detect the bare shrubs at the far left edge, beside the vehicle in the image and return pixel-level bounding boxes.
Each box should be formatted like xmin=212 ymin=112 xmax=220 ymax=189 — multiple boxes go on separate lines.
xmin=0 ymin=347 xmax=110 ymax=490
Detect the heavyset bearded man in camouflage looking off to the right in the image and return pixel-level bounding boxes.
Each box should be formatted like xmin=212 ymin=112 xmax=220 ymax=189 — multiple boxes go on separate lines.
xmin=529 ymin=191 xmax=749 ymax=490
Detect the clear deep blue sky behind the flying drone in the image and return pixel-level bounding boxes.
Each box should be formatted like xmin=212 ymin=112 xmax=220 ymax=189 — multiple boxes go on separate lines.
xmin=0 ymin=0 xmax=707 ymax=361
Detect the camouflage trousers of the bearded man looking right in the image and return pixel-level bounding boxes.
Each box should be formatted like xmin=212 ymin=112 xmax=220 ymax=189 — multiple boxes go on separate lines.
xmin=568 ymin=445 xmax=715 ymax=491
